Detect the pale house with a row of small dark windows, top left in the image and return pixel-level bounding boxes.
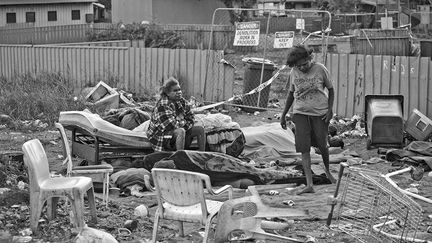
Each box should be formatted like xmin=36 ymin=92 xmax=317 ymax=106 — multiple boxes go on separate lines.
xmin=0 ymin=0 xmax=96 ymax=28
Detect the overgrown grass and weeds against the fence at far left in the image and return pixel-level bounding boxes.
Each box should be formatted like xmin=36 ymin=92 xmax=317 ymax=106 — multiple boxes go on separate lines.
xmin=0 ymin=73 xmax=85 ymax=128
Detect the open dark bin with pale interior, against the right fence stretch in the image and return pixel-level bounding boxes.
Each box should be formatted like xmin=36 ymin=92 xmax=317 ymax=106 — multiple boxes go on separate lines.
xmin=365 ymin=95 xmax=404 ymax=149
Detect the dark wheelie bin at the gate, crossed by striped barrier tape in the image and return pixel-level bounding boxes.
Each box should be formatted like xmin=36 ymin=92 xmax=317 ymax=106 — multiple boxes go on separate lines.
xmin=243 ymin=58 xmax=276 ymax=108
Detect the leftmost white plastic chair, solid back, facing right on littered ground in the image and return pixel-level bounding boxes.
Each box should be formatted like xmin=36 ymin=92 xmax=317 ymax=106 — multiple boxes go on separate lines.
xmin=22 ymin=139 xmax=97 ymax=232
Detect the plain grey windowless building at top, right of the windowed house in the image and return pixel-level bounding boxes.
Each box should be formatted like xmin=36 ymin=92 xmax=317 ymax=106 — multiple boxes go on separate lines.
xmin=111 ymin=0 xmax=229 ymax=24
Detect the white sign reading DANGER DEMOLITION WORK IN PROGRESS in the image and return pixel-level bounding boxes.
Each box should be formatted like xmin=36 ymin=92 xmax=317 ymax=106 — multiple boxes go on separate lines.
xmin=233 ymin=21 xmax=260 ymax=46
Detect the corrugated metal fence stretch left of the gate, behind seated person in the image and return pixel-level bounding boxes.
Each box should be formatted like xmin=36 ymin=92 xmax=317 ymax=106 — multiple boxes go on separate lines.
xmin=0 ymin=45 xmax=234 ymax=101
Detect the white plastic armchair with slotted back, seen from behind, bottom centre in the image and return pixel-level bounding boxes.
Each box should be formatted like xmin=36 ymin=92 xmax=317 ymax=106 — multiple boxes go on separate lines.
xmin=144 ymin=168 xmax=233 ymax=242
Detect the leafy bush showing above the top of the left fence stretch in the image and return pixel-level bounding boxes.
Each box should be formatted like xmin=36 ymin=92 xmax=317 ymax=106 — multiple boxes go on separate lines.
xmin=87 ymin=23 xmax=185 ymax=49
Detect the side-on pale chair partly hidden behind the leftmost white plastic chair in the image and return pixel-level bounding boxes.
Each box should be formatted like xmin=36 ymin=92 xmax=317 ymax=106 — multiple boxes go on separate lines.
xmin=55 ymin=123 xmax=114 ymax=207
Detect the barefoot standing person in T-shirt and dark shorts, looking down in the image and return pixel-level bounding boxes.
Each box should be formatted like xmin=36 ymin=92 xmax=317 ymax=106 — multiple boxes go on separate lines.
xmin=280 ymin=45 xmax=336 ymax=194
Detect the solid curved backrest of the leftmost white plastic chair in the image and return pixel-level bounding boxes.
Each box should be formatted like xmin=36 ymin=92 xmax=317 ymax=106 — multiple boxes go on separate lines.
xmin=22 ymin=139 xmax=50 ymax=189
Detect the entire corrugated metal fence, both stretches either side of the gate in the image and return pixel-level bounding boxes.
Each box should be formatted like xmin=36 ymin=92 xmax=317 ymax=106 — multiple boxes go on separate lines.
xmin=0 ymin=45 xmax=432 ymax=118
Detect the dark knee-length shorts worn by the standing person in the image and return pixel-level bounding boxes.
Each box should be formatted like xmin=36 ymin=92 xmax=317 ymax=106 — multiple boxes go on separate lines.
xmin=292 ymin=114 xmax=329 ymax=153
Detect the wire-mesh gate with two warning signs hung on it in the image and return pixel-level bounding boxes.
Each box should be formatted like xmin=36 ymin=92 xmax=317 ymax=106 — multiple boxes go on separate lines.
xmin=204 ymin=8 xmax=331 ymax=111
